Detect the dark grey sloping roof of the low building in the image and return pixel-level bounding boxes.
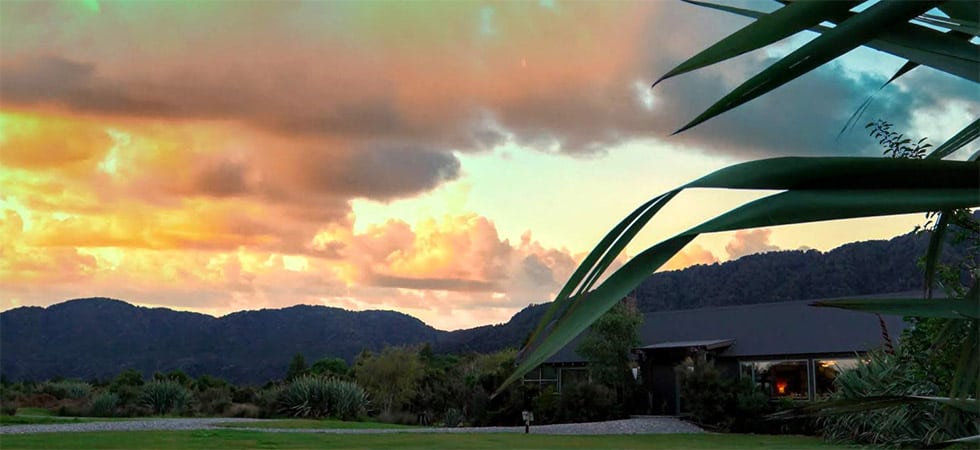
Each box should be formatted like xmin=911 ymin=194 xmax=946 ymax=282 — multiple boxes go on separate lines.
xmin=547 ymin=293 xmax=921 ymax=363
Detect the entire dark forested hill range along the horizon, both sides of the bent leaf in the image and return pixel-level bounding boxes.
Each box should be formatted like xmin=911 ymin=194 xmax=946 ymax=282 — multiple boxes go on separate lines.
xmin=0 ymin=230 xmax=955 ymax=383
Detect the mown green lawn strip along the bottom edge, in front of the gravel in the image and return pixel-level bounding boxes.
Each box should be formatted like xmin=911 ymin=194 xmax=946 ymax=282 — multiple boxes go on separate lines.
xmin=0 ymin=430 xmax=842 ymax=450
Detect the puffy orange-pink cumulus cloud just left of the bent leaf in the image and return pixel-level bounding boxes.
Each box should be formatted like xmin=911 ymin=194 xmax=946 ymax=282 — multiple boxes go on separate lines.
xmin=314 ymin=214 xmax=575 ymax=304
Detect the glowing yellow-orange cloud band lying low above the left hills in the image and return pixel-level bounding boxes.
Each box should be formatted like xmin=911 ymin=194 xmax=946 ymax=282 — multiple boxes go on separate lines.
xmin=0 ymin=195 xmax=576 ymax=328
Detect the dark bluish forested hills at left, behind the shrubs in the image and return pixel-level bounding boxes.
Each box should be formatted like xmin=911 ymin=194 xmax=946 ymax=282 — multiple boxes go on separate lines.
xmin=0 ymin=298 xmax=436 ymax=383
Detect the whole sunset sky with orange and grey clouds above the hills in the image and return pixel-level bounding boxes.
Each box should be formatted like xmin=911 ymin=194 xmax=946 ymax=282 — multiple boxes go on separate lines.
xmin=0 ymin=0 xmax=980 ymax=329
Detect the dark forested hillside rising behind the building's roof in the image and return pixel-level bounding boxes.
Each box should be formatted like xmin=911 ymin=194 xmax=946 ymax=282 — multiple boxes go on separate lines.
xmin=636 ymin=229 xmax=969 ymax=313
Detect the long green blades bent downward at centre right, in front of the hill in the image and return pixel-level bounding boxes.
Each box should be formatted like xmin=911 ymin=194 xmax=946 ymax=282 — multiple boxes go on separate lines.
xmin=498 ymin=158 xmax=980 ymax=392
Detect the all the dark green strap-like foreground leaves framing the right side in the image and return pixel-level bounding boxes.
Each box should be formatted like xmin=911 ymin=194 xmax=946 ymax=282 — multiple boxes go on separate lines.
xmin=504 ymin=0 xmax=980 ymax=442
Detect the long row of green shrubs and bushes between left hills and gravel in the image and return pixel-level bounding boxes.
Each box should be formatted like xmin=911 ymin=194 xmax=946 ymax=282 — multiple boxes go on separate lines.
xmin=0 ymin=345 xmax=625 ymax=427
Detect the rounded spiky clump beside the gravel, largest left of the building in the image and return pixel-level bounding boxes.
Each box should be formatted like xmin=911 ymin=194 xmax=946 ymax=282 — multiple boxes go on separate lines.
xmin=279 ymin=375 xmax=368 ymax=420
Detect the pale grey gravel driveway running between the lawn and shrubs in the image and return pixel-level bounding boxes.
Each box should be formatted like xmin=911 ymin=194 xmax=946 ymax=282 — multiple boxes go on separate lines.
xmin=0 ymin=416 xmax=703 ymax=435
